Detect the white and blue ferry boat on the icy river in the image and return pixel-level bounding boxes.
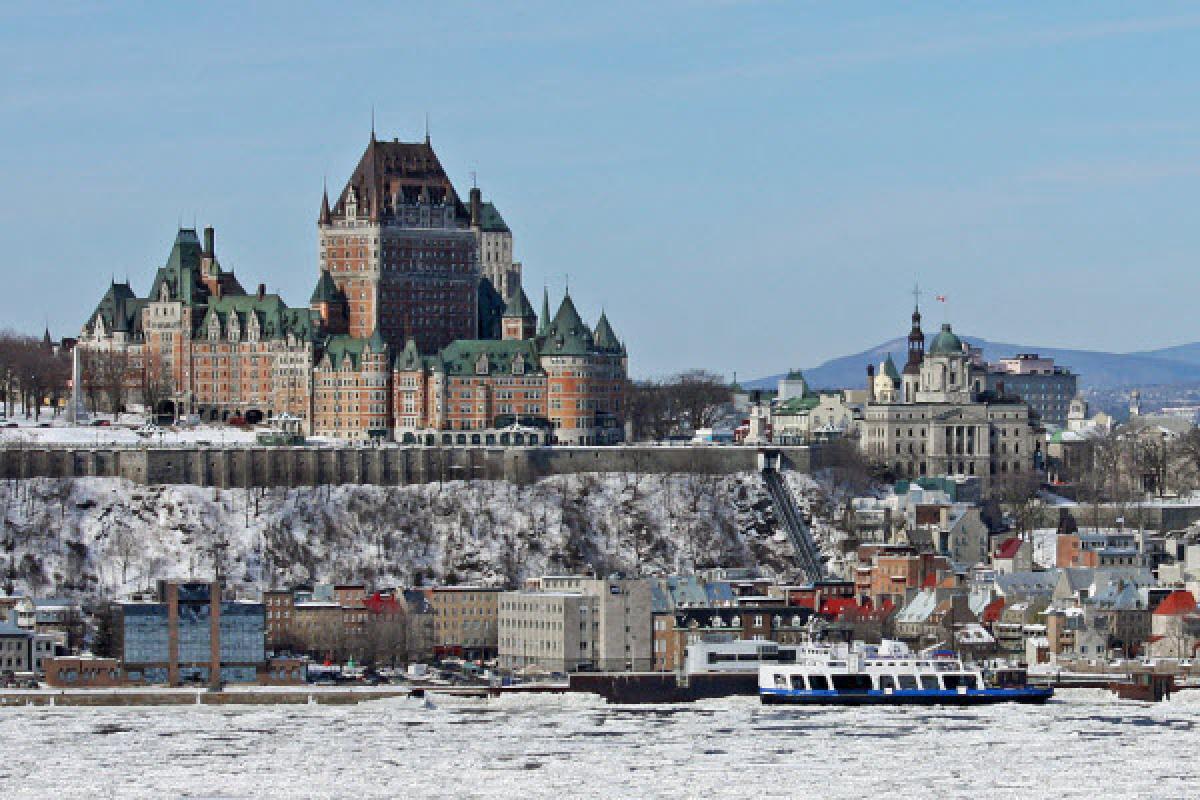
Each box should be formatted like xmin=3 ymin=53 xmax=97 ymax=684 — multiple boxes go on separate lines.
xmin=758 ymin=639 xmax=1054 ymax=705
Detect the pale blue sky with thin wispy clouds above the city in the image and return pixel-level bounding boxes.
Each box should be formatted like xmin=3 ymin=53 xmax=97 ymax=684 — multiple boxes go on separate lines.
xmin=0 ymin=0 xmax=1200 ymax=378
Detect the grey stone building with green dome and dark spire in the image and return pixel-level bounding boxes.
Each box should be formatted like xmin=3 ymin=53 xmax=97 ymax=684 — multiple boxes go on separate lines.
xmin=859 ymin=303 xmax=1039 ymax=485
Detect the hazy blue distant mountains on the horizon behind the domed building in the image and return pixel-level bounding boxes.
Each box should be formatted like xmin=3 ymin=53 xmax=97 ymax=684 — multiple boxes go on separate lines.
xmin=743 ymin=335 xmax=1200 ymax=389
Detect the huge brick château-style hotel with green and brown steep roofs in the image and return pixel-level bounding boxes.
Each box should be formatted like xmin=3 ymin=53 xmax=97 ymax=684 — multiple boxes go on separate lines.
xmin=79 ymin=133 xmax=628 ymax=445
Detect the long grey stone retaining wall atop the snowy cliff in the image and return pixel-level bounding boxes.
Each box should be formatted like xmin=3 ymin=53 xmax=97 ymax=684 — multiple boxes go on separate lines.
xmin=0 ymin=445 xmax=817 ymax=488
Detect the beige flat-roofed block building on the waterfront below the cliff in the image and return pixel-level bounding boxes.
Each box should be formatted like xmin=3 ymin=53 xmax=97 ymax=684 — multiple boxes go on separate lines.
xmin=499 ymin=576 xmax=653 ymax=673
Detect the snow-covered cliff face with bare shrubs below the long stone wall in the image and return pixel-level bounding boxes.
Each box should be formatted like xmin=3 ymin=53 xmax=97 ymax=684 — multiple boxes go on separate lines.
xmin=0 ymin=473 xmax=793 ymax=596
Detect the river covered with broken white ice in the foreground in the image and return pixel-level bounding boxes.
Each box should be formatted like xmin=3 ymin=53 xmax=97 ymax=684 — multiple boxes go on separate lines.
xmin=0 ymin=691 xmax=1200 ymax=800
